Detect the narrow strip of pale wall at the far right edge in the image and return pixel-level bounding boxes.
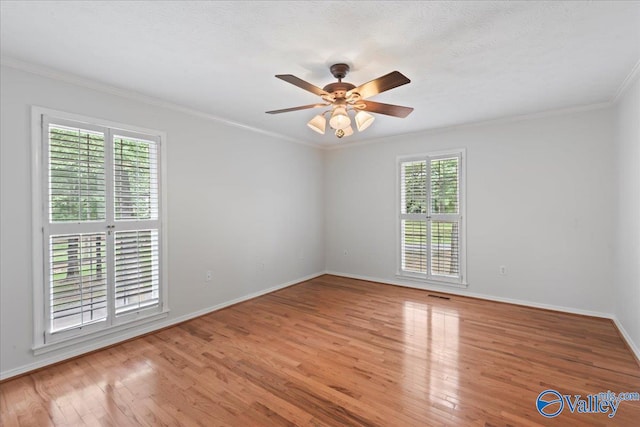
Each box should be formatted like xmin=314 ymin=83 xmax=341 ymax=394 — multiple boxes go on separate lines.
xmin=614 ymin=74 xmax=640 ymax=357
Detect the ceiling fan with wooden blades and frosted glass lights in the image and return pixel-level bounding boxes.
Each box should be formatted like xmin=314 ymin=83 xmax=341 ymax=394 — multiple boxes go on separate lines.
xmin=267 ymin=64 xmax=413 ymax=138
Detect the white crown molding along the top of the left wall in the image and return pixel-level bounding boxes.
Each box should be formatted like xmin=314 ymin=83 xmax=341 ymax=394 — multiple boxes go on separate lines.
xmin=0 ymin=56 xmax=321 ymax=148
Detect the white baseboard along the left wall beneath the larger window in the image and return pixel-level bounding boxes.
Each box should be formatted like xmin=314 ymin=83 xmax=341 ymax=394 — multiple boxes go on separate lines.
xmin=0 ymin=271 xmax=325 ymax=380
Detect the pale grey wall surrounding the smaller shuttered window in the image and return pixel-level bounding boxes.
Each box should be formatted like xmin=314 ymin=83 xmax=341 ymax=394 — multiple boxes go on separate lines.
xmin=325 ymin=109 xmax=615 ymax=315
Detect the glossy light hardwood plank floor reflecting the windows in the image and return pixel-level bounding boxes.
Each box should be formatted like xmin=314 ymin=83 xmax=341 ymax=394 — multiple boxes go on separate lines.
xmin=0 ymin=276 xmax=640 ymax=426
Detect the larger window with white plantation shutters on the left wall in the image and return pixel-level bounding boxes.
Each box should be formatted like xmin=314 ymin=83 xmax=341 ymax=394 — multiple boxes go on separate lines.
xmin=34 ymin=109 xmax=167 ymax=348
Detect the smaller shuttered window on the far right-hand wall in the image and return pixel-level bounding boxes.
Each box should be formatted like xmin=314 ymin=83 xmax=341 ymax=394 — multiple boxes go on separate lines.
xmin=398 ymin=151 xmax=465 ymax=285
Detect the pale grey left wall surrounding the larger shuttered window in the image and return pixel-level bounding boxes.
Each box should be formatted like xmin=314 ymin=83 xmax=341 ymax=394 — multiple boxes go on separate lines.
xmin=0 ymin=66 xmax=325 ymax=378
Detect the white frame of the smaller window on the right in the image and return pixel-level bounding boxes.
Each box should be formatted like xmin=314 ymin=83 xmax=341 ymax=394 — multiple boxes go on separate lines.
xmin=395 ymin=148 xmax=468 ymax=288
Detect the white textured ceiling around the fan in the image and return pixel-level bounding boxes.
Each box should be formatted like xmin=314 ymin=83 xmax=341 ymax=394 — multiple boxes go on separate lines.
xmin=0 ymin=0 xmax=640 ymax=145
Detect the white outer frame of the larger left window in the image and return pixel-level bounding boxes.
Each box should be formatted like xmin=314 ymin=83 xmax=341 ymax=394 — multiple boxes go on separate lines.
xmin=31 ymin=106 xmax=169 ymax=355
